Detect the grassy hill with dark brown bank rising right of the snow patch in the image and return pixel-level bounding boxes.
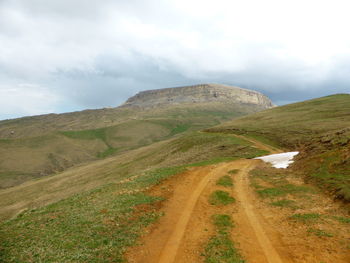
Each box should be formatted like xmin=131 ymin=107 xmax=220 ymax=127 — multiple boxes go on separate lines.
xmin=210 ymin=94 xmax=350 ymax=201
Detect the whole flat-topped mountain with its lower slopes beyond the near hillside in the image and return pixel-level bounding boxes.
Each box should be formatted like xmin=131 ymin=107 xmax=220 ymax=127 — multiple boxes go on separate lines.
xmin=0 ymin=85 xmax=272 ymax=188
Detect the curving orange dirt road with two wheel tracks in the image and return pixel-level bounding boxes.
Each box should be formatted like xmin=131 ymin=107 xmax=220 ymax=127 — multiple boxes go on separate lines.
xmin=127 ymin=137 xmax=292 ymax=263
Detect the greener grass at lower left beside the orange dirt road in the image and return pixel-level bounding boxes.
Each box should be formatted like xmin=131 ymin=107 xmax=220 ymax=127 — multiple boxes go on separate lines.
xmin=0 ymin=167 xmax=184 ymax=262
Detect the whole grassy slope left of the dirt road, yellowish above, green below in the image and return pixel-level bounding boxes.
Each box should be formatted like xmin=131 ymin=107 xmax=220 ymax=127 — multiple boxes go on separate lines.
xmin=0 ymin=132 xmax=266 ymax=262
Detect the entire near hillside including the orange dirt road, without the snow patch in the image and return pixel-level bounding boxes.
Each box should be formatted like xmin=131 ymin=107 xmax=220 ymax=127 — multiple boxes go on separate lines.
xmin=0 ymin=95 xmax=350 ymax=263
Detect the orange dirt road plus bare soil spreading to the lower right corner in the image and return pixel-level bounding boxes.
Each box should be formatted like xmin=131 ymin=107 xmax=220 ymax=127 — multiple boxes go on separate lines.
xmin=126 ymin=136 xmax=346 ymax=263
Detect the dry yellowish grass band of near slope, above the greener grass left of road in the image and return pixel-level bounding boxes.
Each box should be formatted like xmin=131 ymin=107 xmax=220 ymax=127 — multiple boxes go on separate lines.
xmin=0 ymin=132 xmax=270 ymax=223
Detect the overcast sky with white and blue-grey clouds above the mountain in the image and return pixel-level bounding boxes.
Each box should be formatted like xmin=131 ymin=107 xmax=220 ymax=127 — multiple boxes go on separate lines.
xmin=0 ymin=0 xmax=350 ymax=119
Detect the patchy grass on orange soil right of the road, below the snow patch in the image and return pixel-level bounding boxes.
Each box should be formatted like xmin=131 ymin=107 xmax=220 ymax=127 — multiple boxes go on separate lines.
xmin=250 ymin=164 xmax=350 ymax=253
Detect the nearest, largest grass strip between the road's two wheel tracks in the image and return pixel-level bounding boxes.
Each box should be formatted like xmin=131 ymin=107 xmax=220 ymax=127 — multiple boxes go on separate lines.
xmin=202 ymin=214 xmax=245 ymax=263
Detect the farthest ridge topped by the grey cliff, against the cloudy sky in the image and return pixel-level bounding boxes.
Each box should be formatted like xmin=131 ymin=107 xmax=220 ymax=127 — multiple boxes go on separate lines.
xmin=0 ymin=84 xmax=273 ymax=139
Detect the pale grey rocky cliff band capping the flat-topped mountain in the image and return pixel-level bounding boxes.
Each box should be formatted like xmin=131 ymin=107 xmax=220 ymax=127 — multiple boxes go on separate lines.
xmin=122 ymin=84 xmax=274 ymax=109
